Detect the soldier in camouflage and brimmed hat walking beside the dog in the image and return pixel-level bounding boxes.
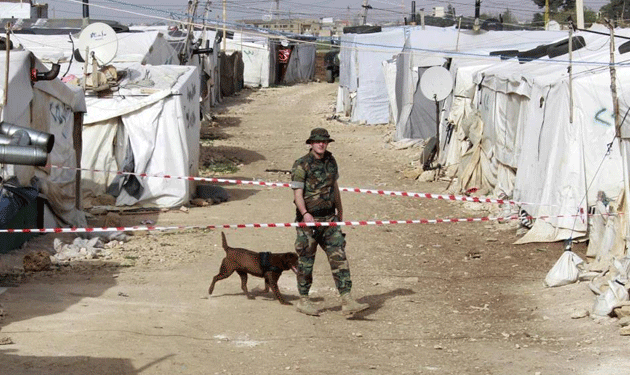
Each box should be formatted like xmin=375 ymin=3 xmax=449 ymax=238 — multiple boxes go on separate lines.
xmin=291 ymin=128 xmax=369 ymax=316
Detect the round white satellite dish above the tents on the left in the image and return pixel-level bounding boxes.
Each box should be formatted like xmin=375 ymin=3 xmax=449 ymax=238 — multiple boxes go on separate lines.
xmin=78 ymin=22 xmax=118 ymax=65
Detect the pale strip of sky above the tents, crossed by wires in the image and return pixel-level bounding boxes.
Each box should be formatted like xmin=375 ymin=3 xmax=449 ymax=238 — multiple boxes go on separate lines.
xmin=43 ymin=0 xmax=609 ymax=24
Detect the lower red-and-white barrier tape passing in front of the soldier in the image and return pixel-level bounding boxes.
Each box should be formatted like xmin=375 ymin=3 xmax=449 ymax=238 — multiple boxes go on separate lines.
xmin=0 ymin=213 xmax=617 ymax=233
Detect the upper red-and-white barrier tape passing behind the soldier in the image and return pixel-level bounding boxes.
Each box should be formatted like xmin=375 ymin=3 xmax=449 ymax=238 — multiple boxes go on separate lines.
xmin=48 ymin=165 xmax=539 ymax=206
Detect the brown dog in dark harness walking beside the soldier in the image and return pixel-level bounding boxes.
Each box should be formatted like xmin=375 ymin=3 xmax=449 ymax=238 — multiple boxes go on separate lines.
xmin=208 ymin=232 xmax=298 ymax=305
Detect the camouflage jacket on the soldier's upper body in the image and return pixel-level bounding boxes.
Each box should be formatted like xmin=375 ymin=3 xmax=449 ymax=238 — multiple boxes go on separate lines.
xmin=291 ymin=151 xmax=339 ymax=218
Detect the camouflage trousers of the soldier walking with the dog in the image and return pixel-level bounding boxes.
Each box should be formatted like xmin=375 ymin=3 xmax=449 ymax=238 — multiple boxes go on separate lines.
xmin=295 ymin=219 xmax=352 ymax=296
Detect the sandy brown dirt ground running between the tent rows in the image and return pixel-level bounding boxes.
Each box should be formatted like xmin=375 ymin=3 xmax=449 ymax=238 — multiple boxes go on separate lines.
xmin=0 ymin=83 xmax=630 ymax=375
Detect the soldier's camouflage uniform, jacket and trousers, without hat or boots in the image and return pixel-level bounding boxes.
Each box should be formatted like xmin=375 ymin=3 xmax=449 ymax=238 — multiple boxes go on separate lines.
xmin=291 ymin=151 xmax=352 ymax=296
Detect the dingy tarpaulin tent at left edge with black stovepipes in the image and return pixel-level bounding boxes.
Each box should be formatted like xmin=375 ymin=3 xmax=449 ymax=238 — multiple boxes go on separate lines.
xmin=0 ymin=51 xmax=86 ymax=227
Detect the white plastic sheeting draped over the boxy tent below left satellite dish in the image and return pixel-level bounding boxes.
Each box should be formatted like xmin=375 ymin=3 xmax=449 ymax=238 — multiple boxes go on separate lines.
xmin=81 ymin=65 xmax=200 ymax=207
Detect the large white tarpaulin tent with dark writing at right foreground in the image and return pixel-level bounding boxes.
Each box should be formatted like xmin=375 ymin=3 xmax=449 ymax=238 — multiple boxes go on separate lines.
xmin=442 ymin=27 xmax=630 ymax=242
